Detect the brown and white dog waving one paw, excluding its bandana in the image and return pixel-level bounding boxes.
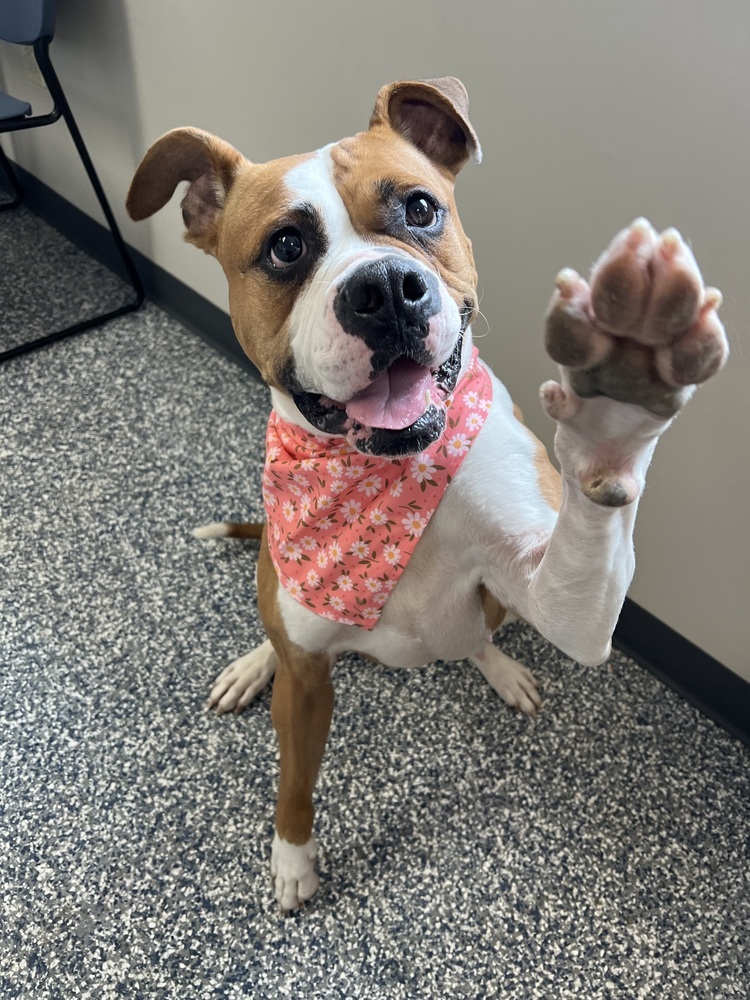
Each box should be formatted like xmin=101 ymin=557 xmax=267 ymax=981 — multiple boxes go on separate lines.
xmin=128 ymin=78 xmax=727 ymax=910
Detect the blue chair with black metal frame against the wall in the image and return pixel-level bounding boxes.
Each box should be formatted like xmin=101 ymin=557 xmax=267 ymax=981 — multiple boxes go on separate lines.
xmin=0 ymin=0 xmax=144 ymax=362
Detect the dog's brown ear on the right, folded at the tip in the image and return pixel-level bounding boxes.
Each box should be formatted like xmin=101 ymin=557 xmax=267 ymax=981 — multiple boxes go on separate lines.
xmin=370 ymin=76 xmax=482 ymax=175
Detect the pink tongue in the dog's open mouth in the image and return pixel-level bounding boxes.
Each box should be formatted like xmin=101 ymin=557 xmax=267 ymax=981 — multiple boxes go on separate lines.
xmin=346 ymin=358 xmax=434 ymax=430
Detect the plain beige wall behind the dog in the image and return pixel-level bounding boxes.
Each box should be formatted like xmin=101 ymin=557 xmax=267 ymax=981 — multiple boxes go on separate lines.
xmin=0 ymin=0 xmax=750 ymax=679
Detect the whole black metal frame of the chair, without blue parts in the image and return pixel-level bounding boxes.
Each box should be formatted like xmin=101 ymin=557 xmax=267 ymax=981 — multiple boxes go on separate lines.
xmin=0 ymin=37 xmax=144 ymax=362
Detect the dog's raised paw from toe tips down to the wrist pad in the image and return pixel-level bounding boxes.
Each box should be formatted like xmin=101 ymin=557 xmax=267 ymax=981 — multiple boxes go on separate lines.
xmin=541 ymin=219 xmax=729 ymax=507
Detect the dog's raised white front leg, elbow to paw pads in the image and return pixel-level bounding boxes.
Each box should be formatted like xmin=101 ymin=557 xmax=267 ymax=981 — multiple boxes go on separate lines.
xmin=491 ymin=219 xmax=728 ymax=665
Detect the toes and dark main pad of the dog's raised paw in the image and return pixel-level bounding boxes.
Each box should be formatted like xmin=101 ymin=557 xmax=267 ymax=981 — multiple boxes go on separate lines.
xmin=545 ymin=219 xmax=729 ymax=419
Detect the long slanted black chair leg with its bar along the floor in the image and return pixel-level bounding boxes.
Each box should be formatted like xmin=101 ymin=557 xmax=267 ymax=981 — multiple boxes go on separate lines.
xmin=0 ymin=38 xmax=144 ymax=363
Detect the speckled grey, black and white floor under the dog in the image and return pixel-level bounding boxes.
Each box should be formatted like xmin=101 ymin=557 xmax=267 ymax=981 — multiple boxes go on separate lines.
xmin=0 ymin=205 xmax=750 ymax=1000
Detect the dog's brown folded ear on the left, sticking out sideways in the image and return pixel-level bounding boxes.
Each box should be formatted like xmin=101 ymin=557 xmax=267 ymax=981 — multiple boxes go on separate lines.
xmin=126 ymin=128 xmax=247 ymax=254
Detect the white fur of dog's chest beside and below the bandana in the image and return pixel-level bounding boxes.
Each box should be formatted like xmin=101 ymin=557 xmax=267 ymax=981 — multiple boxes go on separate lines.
xmin=279 ymin=368 xmax=555 ymax=667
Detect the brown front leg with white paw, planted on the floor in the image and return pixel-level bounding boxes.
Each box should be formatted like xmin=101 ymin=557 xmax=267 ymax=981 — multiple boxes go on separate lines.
xmin=258 ymin=530 xmax=334 ymax=910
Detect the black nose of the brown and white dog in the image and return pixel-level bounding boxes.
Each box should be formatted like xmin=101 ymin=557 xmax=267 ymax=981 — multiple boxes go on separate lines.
xmin=334 ymin=256 xmax=440 ymax=354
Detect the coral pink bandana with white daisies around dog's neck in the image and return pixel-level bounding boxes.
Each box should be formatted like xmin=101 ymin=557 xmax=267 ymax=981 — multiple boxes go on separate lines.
xmin=263 ymin=348 xmax=492 ymax=630
